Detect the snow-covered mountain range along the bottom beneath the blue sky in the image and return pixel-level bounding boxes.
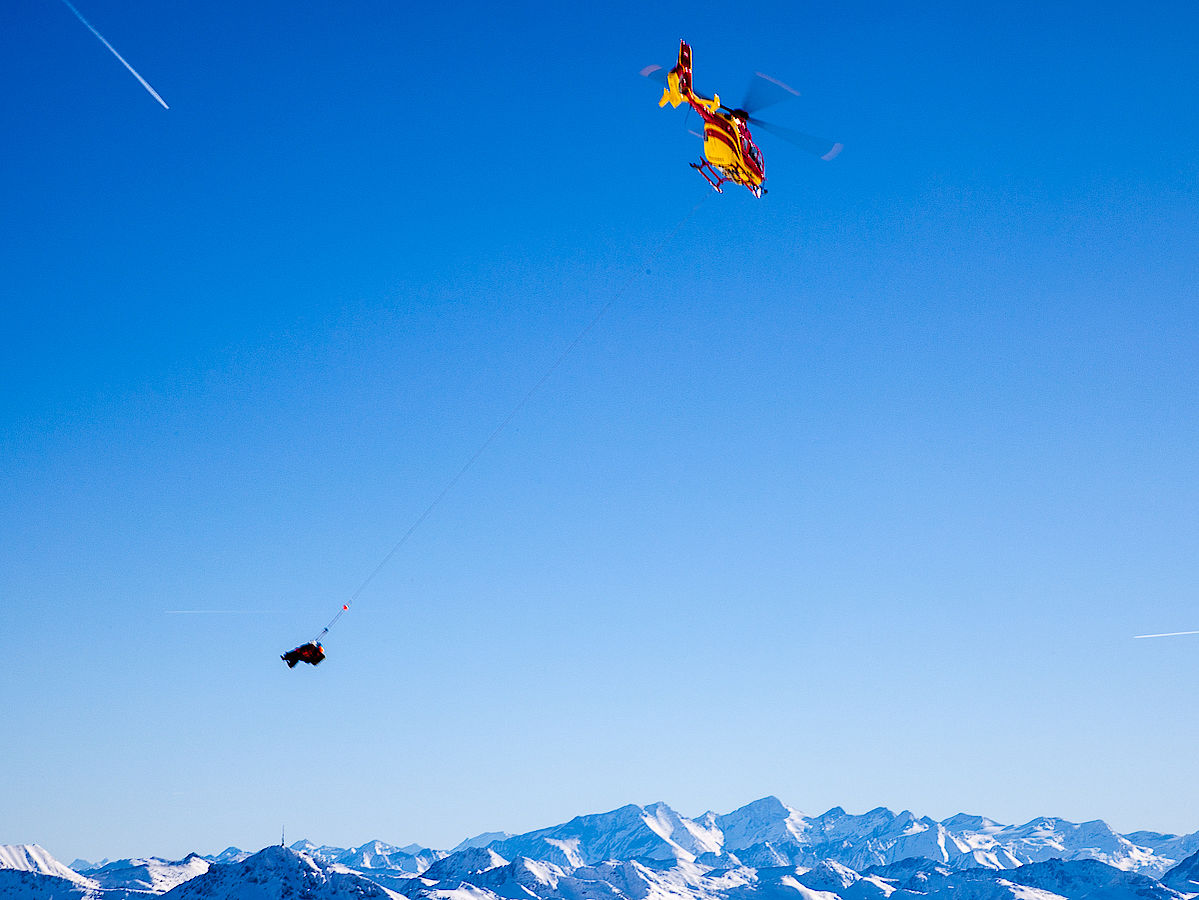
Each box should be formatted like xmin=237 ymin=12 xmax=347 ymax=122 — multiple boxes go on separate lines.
xmin=0 ymin=797 xmax=1199 ymax=900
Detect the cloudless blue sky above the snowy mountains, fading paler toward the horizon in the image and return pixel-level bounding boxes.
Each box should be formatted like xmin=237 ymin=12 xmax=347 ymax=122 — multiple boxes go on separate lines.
xmin=0 ymin=0 xmax=1199 ymax=862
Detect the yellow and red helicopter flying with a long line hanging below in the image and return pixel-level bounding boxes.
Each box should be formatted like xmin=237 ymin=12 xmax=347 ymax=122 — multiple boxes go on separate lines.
xmin=641 ymin=41 xmax=842 ymax=198
